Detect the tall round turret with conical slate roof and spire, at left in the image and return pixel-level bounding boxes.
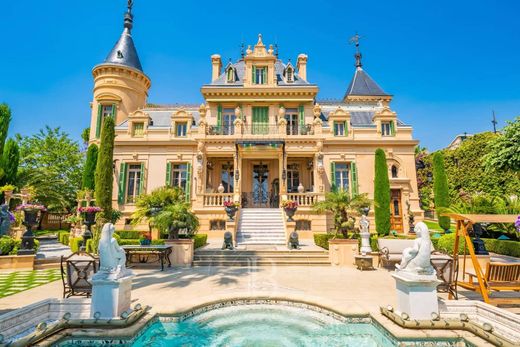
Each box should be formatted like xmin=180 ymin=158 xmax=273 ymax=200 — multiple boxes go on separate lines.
xmin=90 ymin=0 xmax=151 ymax=140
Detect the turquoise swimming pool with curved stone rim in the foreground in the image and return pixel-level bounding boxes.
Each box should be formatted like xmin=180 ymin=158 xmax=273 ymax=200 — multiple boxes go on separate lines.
xmin=60 ymin=302 xmax=472 ymax=347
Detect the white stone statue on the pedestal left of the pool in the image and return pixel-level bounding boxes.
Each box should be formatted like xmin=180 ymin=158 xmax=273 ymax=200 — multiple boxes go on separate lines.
xmin=94 ymin=223 xmax=132 ymax=279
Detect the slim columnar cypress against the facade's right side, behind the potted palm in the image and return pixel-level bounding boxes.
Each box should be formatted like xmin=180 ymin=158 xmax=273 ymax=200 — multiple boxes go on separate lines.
xmin=374 ymin=148 xmax=390 ymax=236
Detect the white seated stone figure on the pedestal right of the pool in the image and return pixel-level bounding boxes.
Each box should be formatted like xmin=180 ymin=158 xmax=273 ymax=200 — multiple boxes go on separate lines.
xmin=395 ymin=222 xmax=435 ymax=275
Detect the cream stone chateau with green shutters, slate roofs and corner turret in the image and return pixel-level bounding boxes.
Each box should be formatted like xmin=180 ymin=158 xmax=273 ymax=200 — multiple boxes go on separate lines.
xmin=90 ymin=4 xmax=423 ymax=243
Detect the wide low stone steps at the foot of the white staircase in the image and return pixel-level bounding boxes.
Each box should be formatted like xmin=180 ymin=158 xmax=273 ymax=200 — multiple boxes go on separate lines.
xmin=193 ymin=249 xmax=330 ymax=267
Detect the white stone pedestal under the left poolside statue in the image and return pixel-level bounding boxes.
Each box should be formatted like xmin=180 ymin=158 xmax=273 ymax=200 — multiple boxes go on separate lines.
xmin=90 ymin=275 xmax=134 ymax=319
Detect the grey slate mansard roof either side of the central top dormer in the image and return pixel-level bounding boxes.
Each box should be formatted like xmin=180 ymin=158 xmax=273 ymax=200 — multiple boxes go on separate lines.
xmin=205 ymin=59 xmax=315 ymax=87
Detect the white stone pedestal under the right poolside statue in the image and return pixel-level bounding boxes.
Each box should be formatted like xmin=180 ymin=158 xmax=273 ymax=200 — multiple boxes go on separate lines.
xmin=392 ymin=271 xmax=441 ymax=320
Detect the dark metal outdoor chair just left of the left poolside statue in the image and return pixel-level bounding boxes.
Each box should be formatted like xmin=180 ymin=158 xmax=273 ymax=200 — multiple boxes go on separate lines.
xmin=61 ymin=251 xmax=99 ymax=298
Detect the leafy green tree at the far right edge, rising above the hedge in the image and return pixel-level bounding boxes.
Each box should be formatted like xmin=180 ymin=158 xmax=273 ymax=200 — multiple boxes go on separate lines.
xmin=485 ymin=117 xmax=520 ymax=176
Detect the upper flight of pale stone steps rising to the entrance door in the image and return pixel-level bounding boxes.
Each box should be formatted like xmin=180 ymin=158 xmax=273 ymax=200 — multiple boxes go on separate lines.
xmin=237 ymin=208 xmax=286 ymax=245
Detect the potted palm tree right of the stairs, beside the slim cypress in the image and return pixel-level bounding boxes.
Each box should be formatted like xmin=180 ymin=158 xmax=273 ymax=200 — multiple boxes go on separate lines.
xmin=314 ymin=190 xmax=371 ymax=238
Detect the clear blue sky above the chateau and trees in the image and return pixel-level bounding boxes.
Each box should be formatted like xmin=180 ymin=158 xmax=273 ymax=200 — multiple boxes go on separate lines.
xmin=0 ymin=0 xmax=520 ymax=150
